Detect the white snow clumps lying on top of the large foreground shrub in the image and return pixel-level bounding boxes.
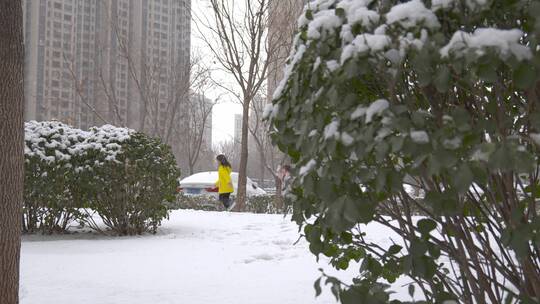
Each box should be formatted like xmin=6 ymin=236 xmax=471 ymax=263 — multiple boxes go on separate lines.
xmin=273 ymin=0 xmax=532 ymax=97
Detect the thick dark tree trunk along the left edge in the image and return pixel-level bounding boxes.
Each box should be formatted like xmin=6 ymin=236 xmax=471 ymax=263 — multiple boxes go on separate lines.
xmin=0 ymin=0 xmax=24 ymax=304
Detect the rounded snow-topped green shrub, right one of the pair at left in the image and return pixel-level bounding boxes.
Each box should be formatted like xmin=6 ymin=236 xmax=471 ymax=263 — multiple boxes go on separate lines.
xmin=71 ymin=125 xmax=180 ymax=235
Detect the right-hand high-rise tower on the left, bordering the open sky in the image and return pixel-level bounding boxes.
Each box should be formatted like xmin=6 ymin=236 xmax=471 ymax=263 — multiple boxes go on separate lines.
xmin=132 ymin=0 xmax=191 ymax=134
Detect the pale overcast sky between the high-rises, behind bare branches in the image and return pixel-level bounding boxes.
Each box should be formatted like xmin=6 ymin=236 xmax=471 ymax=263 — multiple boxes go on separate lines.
xmin=191 ymin=0 xmax=242 ymax=146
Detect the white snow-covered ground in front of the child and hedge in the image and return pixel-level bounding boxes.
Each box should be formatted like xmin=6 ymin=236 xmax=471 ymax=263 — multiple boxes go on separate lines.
xmin=20 ymin=210 xmax=410 ymax=304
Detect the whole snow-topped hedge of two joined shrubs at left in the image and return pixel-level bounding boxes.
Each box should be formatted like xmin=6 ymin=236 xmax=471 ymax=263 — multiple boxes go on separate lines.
xmin=23 ymin=121 xmax=179 ymax=235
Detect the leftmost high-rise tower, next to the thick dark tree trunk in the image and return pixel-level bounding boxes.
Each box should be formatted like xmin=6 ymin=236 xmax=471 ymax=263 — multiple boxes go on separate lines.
xmin=22 ymin=0 xmax=97 ymax=126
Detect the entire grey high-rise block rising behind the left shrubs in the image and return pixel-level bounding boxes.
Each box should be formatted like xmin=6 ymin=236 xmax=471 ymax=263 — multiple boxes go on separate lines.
xmin=22 ymin=0 xmax=191 ymax=131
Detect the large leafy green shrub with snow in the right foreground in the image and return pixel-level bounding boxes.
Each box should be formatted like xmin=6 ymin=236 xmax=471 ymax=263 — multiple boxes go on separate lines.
xmin=266 ymin=0 xmax=540 ymax=303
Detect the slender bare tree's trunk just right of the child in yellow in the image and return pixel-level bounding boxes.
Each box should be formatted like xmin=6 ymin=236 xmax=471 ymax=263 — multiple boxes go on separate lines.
xmin=236 ymin=101 xmax=249 ymax=211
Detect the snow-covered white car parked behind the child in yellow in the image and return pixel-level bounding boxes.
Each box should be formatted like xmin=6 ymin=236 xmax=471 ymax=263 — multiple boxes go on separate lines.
xmin=179 ymin=171 xmax=266 ymax=198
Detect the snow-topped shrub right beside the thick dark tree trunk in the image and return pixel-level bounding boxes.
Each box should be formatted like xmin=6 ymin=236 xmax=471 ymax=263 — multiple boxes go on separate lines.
xmin=23 ymin=121 xmax=86 ymax=233
